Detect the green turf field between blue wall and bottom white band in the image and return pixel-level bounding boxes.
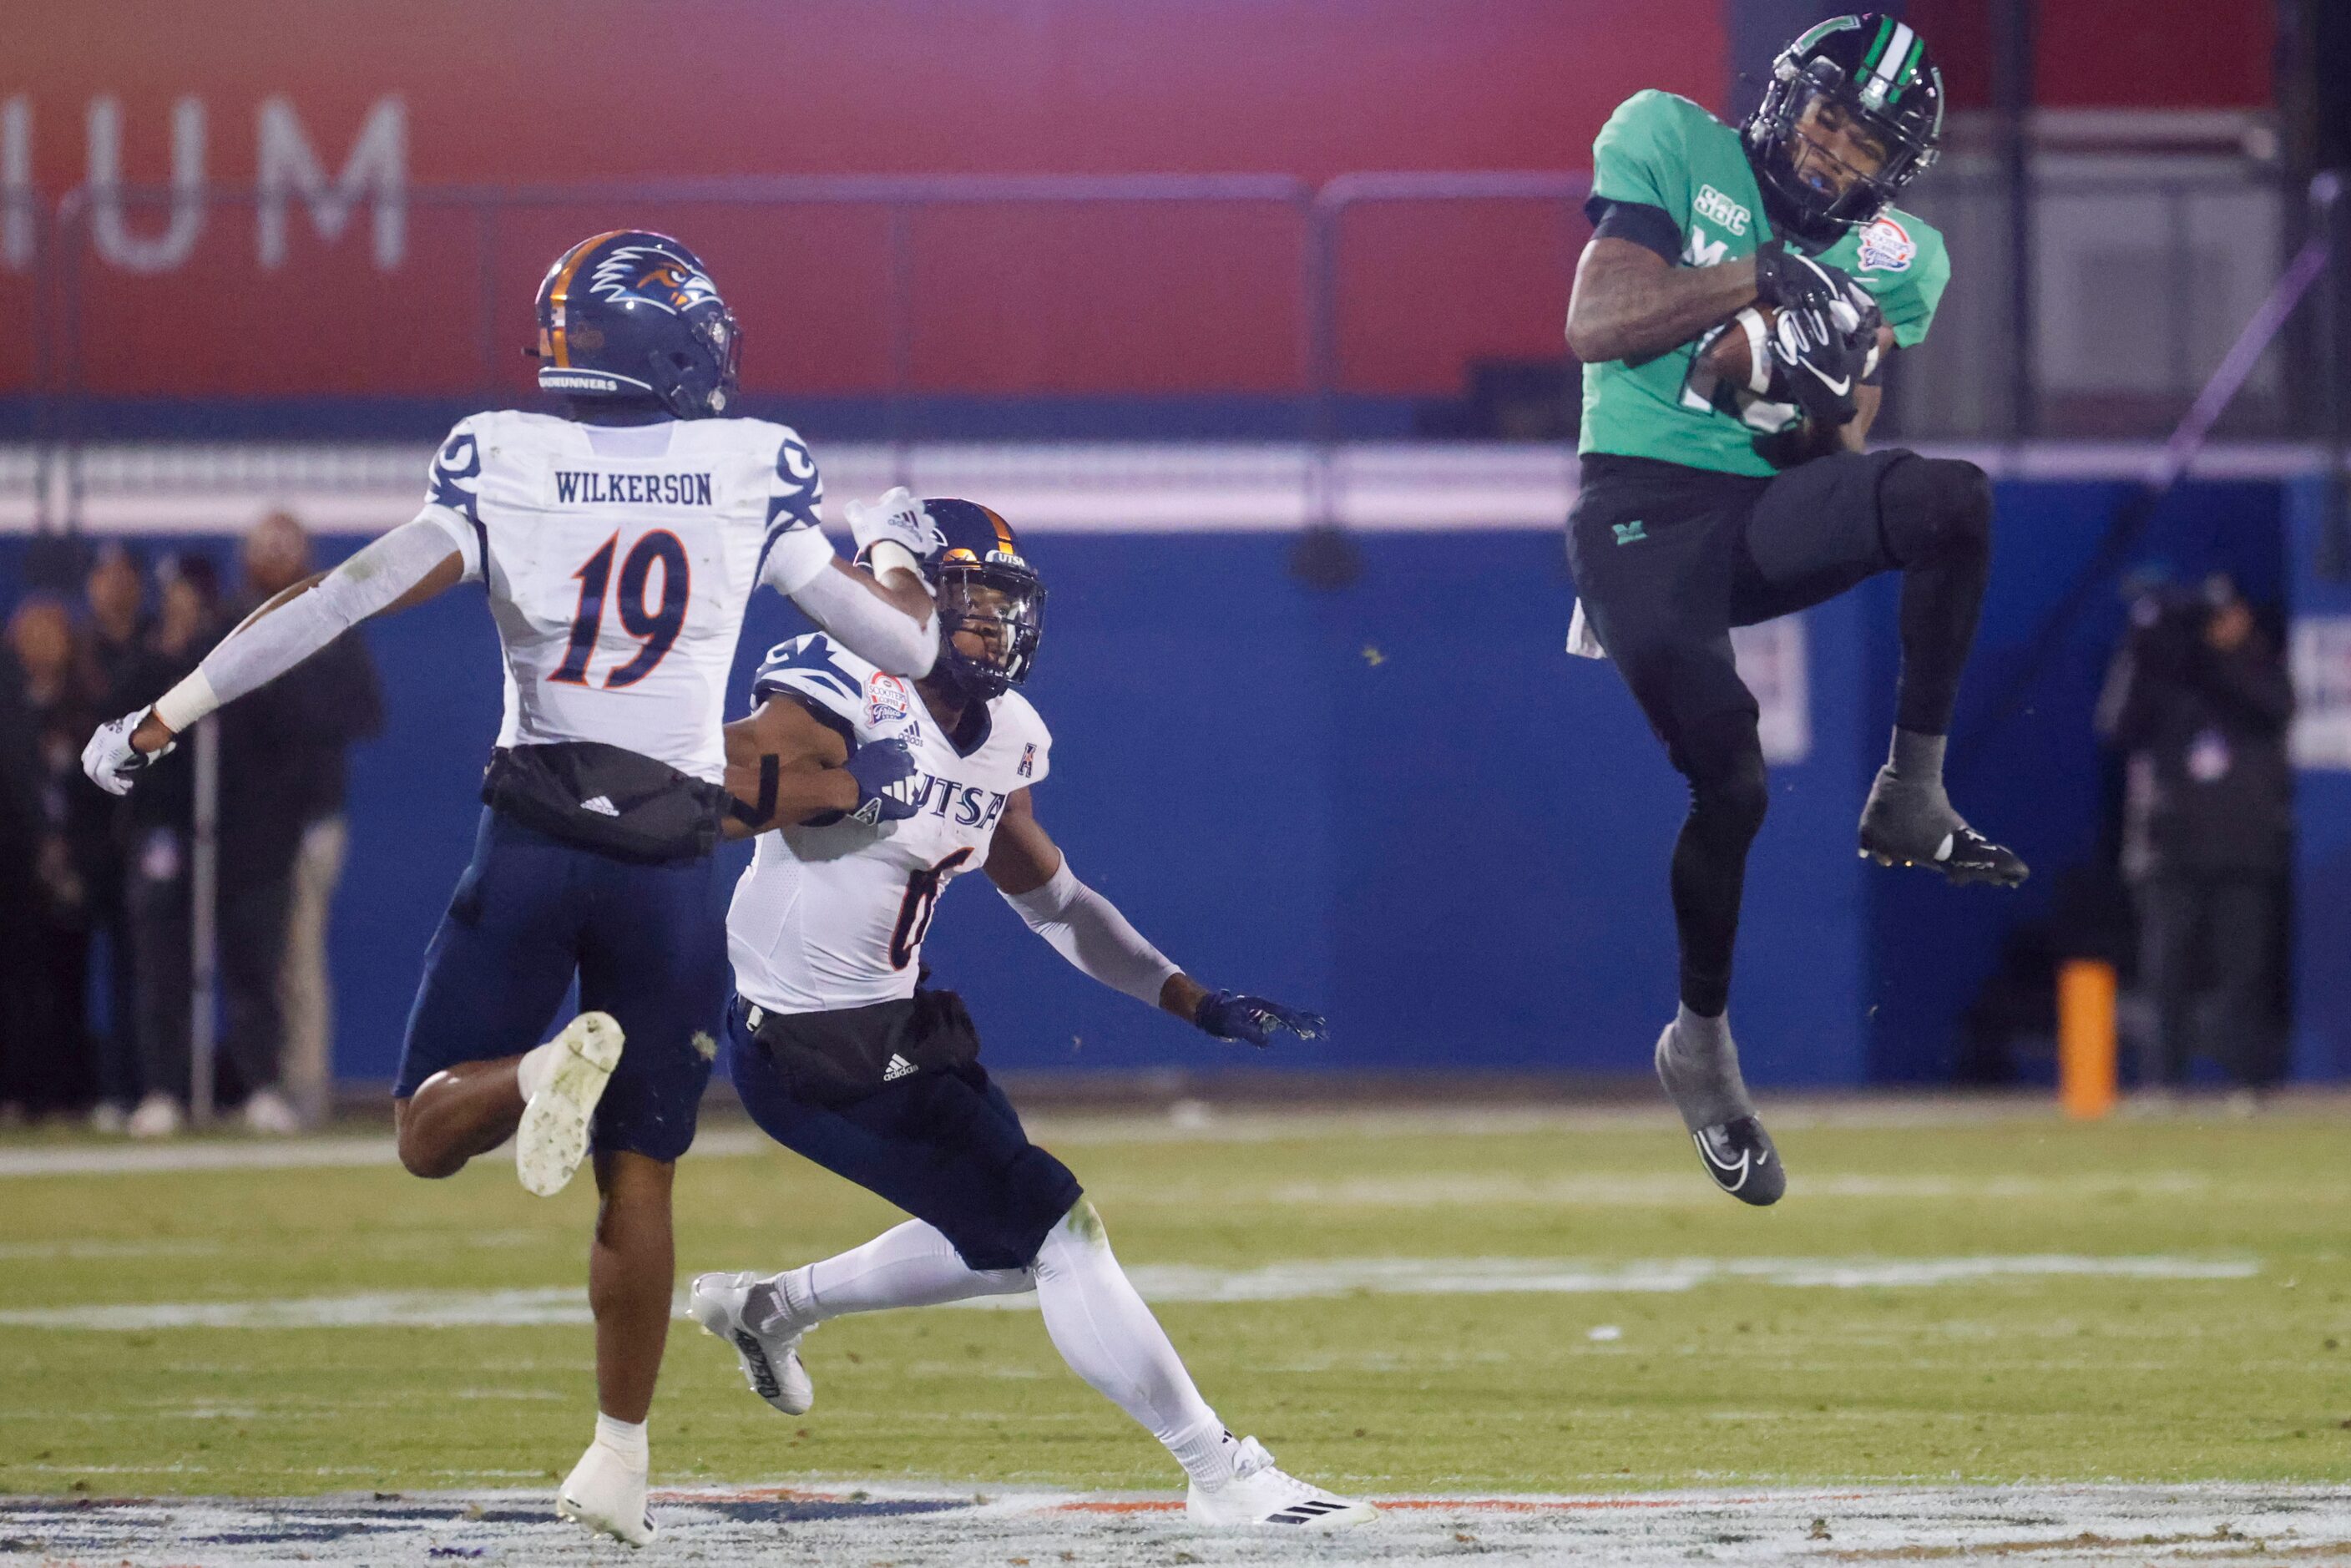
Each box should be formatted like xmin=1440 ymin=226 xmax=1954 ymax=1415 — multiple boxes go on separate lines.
xmin=0 ymin=1105 xmax=2351 ymax=1495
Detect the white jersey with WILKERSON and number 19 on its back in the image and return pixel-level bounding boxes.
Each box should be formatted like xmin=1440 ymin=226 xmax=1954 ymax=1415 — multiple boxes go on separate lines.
xmin=423 ymin=412 xmax=832 ymax=783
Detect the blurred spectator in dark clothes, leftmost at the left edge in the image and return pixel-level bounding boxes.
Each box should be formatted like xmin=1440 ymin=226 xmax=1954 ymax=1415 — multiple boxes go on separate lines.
xmin=0 ymin=593 xmax=109 ymax=1116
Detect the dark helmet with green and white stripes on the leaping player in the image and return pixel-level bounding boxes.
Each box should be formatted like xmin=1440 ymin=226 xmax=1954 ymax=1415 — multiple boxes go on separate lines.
xmin=1744 ymin=12 xmax=1942 ymax=245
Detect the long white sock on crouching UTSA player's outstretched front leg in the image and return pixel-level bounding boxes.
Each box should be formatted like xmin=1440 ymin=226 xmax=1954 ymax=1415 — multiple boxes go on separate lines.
xmin=1034 ymin=1201 xmax=1239 ymax=1488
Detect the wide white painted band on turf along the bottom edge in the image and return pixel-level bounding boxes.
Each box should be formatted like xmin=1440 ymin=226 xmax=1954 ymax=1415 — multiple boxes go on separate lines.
xmin=0 ymin=1481 xmax=2351 ymax=1568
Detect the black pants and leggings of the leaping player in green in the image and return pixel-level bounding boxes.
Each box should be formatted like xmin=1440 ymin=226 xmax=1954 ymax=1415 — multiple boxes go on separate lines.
xmin=1568 ymin=452 xmax=1991 ymax=1018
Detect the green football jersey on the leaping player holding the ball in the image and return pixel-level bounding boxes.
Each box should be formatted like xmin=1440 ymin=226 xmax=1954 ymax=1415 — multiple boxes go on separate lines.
xmin=1578 ymin=92 xmax=1951 ymax=475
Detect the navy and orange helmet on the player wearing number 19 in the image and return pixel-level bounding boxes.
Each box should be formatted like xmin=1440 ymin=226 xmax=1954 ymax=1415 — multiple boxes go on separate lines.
xmin=538 ymin=228 xmax=743 ymax=418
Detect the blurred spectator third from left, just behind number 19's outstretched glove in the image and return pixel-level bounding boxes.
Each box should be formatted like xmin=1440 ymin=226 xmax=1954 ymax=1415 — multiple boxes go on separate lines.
xmin=115 ymin=554 xmax=224 ymax=1138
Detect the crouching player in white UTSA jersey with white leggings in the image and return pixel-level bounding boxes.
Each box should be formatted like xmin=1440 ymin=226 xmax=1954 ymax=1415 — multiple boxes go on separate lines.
xmin=689 ymin=491 xmax=1373 ymax=1528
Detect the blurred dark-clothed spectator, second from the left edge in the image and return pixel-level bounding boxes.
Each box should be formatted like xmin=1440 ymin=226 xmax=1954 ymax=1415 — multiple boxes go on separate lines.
xmin=78 ymin=541 xmax=155 ymax=1133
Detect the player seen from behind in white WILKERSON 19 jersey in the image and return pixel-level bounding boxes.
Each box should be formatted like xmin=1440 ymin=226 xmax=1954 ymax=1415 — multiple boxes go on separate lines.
xmin=83 ymin=230 xmax=938 ymax=1545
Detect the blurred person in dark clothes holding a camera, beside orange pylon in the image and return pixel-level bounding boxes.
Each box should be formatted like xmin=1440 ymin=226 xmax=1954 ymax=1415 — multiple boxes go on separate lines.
xmin=2100 ymin=576 xmax=2294 ymax=1093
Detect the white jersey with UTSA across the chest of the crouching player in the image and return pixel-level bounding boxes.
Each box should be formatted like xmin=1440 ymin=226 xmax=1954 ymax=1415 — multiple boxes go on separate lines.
xmin=726 ymin=632 xmax=1054 ymax=1014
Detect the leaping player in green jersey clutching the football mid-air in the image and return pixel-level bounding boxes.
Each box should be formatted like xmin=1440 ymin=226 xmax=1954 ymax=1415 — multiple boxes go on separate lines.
xmin=1568 ymin=14 xmax=2025 ymax=1204
